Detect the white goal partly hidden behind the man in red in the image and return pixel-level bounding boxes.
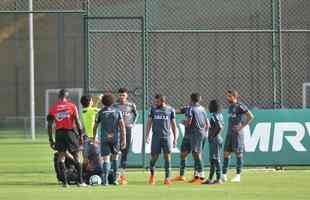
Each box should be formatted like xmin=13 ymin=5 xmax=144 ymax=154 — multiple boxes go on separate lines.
xmin=44 ymin=88 xmax=83 ymax=126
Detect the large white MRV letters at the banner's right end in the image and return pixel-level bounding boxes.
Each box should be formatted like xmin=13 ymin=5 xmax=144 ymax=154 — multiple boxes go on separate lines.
xmin=244 ymin=122 xmax=310 ymax=152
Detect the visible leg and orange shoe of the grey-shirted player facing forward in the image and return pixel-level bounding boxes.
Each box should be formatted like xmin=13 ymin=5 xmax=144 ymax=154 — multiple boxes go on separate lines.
xmin=120 ymin=128 xmax=132 ymax=185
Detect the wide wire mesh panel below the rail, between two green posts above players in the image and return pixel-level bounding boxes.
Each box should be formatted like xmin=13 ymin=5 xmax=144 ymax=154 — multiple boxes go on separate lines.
xmin=149 ymin=32 xmax=273 ymax=108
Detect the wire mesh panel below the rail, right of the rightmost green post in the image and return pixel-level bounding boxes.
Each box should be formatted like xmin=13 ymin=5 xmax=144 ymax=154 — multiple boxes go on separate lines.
xmin=282 ymin=32 xmax=310 ymax=108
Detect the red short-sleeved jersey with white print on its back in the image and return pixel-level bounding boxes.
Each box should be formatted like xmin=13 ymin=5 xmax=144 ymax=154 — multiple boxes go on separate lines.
xmin=49 ymin=101 xmax=78 ymax=129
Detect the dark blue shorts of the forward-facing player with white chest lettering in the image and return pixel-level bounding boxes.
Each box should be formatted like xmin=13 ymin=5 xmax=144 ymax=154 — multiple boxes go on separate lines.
xmin=151 ymin=135 xmax=172 ymax=155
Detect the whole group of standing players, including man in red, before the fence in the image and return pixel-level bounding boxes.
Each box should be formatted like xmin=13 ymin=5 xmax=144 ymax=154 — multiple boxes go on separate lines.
xmin=47 ymin=88 xmax=253 ymax=187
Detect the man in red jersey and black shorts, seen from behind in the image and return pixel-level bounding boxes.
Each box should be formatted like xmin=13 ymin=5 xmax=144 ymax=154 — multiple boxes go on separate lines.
xmin=47 ymin=89 xmax=86 ymax=187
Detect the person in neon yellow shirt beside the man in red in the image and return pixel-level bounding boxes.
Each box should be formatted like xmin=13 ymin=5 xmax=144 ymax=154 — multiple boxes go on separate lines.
xmin=80 ymin=95 xmax=99 ymax=172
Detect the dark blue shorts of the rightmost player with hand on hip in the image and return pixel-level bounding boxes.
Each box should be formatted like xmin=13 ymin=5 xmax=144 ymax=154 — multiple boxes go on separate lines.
xmin=224 ymin=131 xmax=244 ymax=153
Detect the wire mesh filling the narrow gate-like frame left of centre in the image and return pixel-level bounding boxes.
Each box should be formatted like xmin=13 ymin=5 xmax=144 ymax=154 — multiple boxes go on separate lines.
xmin=89 ymin=18 xmax=143 ymax=109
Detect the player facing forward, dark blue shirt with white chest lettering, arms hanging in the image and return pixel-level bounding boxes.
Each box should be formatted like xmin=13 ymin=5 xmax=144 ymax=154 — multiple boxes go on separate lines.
xmin=146 ymin=94 xmax=177 ymax=185
